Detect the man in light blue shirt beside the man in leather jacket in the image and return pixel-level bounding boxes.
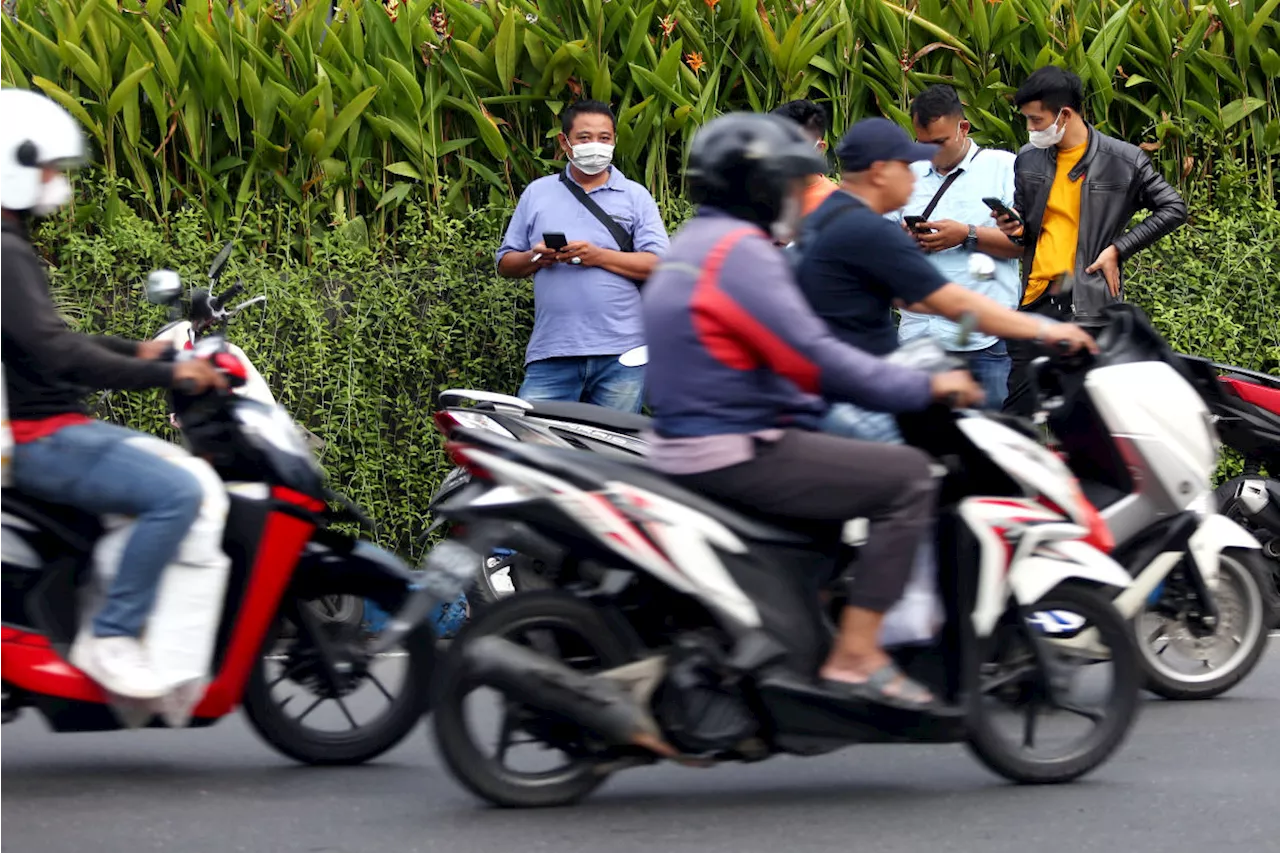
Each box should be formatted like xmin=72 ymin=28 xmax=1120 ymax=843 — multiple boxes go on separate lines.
xmin=893 ymin=85 xmax=1021 ymax=411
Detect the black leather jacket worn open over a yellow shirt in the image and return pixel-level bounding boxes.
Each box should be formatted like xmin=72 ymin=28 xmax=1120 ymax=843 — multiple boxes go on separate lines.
xmin=1014 ymin=127 xmax=1187 ymax=325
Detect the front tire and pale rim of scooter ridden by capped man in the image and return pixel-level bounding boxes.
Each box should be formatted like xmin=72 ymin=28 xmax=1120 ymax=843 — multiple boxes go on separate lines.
xmin=1133 ymin=549 xmax=1274 ymax=699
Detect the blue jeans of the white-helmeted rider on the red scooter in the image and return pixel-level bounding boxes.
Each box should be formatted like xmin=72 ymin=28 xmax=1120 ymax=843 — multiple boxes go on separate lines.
xmin=13 ymin=421 xmax=205 ymax=638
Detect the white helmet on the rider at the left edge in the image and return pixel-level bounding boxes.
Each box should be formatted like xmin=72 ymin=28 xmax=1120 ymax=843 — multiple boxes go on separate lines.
xmin=0 ymin=88 xmax=84 ymax=216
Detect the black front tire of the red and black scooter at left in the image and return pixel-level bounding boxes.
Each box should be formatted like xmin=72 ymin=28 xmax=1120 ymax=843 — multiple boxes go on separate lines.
xmin=243 ymin=579 xmax=435 ymax=766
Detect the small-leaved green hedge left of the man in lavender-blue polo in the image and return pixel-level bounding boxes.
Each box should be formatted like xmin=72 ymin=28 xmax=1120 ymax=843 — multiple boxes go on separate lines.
xmin=38 ymin=178 xmax=532 ymax=552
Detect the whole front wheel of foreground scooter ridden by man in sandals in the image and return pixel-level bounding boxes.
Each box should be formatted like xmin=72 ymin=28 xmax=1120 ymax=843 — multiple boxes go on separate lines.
xmin=968 ymin=583 xmax=1142 ymax=784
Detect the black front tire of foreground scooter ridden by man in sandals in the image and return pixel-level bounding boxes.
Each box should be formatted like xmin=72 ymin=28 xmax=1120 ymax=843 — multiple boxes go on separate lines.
xmin=966 ymin=583 xmax=1142 ymax=785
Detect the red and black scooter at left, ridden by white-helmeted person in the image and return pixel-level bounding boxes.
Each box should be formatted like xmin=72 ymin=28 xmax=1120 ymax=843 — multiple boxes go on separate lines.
xmin=0 ymin=313 xmax=435 ymax=765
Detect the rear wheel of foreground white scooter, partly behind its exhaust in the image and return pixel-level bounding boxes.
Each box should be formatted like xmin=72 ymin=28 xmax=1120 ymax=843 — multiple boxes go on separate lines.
xmin=435 ymin=590 xmax=630 ymax=808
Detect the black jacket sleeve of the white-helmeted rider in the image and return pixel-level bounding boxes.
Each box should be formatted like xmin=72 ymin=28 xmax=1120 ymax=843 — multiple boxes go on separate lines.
xmin=0 ymin=244 xmax=173 ymax=391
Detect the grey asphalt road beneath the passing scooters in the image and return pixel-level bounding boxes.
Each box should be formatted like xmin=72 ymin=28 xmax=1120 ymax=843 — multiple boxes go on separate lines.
xmin=0 ymin=640 xmax=1280 ymax=853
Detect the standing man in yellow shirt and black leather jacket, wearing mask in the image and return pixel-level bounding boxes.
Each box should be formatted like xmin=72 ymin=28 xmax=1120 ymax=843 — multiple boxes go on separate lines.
xmin=997 ymin=65 xmax=1187 ymax=415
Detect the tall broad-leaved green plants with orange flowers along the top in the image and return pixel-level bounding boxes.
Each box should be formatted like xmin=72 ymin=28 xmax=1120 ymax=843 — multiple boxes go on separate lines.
xmin=0 ymin=0 xmax=1280 ymax=247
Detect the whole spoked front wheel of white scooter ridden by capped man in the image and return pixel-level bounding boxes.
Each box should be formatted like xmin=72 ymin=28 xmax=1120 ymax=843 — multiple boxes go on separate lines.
xmin=1133 ymin=551 xmax=1272 ymax=699
